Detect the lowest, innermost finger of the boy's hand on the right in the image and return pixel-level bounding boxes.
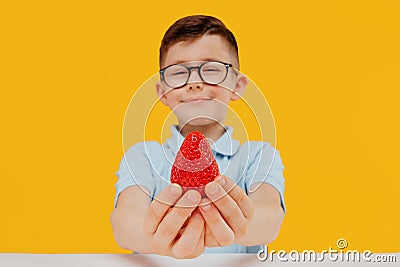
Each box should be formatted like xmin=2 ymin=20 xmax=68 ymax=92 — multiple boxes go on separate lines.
xmin=199 ymin=198 xmax=235 ymax=246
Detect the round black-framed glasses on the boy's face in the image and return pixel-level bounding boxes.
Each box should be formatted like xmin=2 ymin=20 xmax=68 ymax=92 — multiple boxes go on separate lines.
xmin=160 ymin=61 xmax=232 ymax=88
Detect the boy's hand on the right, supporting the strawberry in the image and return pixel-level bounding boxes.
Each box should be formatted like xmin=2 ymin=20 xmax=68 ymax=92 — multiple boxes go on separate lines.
xmin=199 ymin=176 xmax=254 ymax=247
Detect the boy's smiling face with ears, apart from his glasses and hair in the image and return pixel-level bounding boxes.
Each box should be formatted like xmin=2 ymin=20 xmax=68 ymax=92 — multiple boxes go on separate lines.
xmin=156 ymin=35 xmax=247 ymax=126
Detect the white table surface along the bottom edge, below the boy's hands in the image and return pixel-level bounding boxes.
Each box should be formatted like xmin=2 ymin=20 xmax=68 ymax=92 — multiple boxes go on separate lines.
xmin=0 ymin=253 xmax=400 ymax=267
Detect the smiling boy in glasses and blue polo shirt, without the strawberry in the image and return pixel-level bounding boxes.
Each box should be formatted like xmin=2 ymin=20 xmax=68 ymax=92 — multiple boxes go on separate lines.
xmin=111 ymin=16 xmax=285 ymax=258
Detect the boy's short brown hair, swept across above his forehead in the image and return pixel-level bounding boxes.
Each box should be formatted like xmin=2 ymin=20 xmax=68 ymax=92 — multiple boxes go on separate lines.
xmin=159 ymin=15 xmax=239 ymax=67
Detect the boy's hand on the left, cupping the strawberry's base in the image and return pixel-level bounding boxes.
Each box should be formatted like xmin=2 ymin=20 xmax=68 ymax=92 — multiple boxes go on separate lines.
xmin=143 ymin=184 xmax=205 ymax=258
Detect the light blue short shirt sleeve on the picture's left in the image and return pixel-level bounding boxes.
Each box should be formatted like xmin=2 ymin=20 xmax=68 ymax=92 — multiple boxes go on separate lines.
xmin=114 ymin=143 xmax=155 ymax=207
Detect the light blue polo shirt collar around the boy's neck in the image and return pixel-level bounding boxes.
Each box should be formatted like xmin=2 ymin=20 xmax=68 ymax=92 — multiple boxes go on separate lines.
xmin=167 ymin=125 xmax=240 ymax=156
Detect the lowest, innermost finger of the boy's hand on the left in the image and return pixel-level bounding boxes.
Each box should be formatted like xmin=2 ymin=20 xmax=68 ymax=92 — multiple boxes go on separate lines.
xmin=172 ymin=211 xmax=204 ymax=258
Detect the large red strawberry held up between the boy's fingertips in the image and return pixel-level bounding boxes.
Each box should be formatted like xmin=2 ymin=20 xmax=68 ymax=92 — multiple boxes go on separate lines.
xmin=171 ymin=132 xmax=219 ymax=196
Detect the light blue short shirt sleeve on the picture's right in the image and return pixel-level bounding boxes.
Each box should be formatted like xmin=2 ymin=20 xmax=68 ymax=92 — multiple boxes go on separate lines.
xmin=246 ymin=142 xmax=286 ymax=212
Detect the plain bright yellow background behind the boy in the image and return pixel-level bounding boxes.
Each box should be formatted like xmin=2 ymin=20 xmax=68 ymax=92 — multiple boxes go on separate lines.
xmin=0 ymin=0 xmax=400 ymax=253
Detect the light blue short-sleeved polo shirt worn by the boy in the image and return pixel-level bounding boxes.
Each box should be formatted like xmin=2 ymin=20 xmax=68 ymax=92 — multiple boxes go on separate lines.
xmin=114 ymin=125 xmax=286 ymax=253
